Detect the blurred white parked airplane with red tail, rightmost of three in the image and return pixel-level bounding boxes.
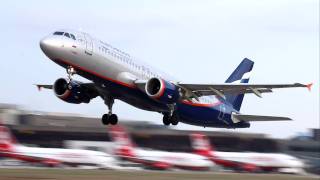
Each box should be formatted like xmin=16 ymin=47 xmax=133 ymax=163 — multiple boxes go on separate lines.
xmin=190 ymin=133 xmax=305 ymax=174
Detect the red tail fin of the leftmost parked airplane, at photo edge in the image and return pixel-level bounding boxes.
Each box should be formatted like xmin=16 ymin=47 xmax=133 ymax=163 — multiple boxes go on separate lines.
xmin=0 ymin=125 xmax=17 ymax=152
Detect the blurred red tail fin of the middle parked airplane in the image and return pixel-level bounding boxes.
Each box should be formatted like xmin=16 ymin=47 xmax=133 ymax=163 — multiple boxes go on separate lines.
xmin=110 ymin=125 xmax=134 ymax=157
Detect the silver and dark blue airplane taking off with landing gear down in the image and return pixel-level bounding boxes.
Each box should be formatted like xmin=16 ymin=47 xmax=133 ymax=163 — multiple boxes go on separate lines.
xmin=36 ymin=30 xmax=312 ymax=128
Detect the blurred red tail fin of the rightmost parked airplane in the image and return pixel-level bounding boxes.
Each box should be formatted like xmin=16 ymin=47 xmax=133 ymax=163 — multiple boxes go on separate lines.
xmin=191 ymin=133 xmax=213 ymax=156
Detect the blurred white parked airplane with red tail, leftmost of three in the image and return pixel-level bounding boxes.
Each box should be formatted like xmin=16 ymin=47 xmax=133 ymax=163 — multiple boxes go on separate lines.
xmin=0 ymin=125 xmax=118 ymax=169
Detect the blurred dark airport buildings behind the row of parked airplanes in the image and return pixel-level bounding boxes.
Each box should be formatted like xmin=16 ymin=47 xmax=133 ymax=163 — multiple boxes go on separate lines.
xmin=0 ymin=104 xmax=320 ymax=174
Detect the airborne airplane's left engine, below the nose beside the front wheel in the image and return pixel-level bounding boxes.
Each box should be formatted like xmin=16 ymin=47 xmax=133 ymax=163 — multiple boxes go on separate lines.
xmin=53 ymin=78 xmax=91 ymax=104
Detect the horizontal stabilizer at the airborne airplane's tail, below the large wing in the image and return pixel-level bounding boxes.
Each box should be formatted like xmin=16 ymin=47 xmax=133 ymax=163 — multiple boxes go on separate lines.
xmin=232 ymin=114 xmax=292 ymax=123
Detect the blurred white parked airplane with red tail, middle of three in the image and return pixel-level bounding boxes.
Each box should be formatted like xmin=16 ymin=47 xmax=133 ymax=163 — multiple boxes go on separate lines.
xmin=109 ymin=125 xmax=215 ymax=171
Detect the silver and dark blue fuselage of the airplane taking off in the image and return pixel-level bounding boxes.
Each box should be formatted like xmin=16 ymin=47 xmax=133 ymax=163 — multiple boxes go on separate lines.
xmin=40 ymin=30 xmax=262 ymax=128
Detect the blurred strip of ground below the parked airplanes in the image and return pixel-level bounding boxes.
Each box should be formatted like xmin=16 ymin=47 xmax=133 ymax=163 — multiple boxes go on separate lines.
xmin=0 ymin=168 xmax=319 ymax=180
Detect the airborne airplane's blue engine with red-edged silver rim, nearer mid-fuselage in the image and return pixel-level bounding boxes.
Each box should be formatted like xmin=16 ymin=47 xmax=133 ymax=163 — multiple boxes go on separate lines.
xmin=145 ymin=78 xmax=180 ymax=104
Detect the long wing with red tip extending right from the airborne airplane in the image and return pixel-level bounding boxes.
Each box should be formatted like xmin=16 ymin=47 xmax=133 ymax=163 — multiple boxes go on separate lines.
xmin=177 ymin=83 xmax=312 ymax=98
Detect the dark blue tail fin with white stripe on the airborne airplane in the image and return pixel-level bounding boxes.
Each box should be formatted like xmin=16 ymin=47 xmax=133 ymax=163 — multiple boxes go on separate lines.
xmin=226 ymin=58 xmax=254 ymax=111
